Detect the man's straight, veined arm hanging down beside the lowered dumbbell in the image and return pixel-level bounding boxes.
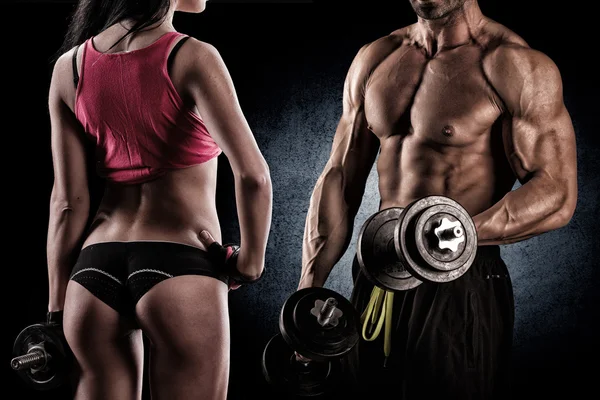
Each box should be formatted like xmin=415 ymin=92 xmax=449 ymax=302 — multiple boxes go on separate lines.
xmin=302 ymin=45 xmax=378 ymax=276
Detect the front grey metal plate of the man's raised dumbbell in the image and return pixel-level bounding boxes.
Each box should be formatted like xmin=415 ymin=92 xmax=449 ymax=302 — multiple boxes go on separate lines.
xmin=394 ymin=196 xmax=477 ymax=283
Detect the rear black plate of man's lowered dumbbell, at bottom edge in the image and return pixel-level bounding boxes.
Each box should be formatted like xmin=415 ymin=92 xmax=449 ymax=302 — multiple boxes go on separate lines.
xmin=262 ymin=334 xmax=343 ymax=397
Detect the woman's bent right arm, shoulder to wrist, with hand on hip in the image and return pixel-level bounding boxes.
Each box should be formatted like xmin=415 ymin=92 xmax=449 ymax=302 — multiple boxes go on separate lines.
xmin=184 ymin=39 xmax=272 ymax=280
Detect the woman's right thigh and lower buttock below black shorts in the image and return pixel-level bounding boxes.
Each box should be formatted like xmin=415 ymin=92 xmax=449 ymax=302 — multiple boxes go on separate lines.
xmin=136 ymin=275 xmax=230 ymax=400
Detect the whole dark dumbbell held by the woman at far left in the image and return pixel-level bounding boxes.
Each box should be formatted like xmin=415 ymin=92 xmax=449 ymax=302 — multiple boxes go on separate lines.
xmin=10 ymin=324 xmax=71 ymax=391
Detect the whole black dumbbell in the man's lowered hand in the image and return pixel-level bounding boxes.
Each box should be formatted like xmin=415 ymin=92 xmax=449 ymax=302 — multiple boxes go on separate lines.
xmin=262 ymin=288 xmax=359 ymax=397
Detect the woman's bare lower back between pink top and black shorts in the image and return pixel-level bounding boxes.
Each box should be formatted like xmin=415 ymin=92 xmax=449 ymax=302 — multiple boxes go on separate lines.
xmin=84 ymin=159 xmax=221 ymax=248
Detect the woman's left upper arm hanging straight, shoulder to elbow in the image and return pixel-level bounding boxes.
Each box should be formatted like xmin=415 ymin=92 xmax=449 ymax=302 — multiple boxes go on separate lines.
xmin=48 ymin=52 xmax=89 ymax=203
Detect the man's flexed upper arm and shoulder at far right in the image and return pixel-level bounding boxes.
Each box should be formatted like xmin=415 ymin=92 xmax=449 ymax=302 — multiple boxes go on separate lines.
xmin=484 ymin=45 xmax=577 ymax=206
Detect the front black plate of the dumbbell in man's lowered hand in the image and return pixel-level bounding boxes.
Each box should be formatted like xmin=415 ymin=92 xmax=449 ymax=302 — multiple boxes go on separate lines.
xmin=279 ymin=287 xmax=360 ymax=361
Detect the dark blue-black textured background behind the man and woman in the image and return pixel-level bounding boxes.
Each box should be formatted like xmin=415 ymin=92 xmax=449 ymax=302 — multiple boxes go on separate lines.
xmin=1 ymin=0 xmax=600 ymax=399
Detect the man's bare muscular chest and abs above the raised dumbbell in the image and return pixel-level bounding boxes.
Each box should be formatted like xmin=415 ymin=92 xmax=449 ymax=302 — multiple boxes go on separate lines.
xmin=364 ymin=23 xmax=526 ymax=215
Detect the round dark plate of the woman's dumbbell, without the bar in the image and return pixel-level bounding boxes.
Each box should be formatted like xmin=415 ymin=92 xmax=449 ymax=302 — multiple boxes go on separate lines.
xmin=13 ymin=324 xmax=69 ymax=391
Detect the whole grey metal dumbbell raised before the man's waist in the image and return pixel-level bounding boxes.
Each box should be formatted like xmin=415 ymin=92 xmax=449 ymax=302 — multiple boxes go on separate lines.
xmin=357 ymin=196 xmax=477 ymax=291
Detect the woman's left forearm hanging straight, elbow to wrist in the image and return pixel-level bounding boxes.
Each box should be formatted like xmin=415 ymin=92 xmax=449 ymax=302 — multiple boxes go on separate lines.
xmin=46 ymin=197 xmax=89 ymax=311
